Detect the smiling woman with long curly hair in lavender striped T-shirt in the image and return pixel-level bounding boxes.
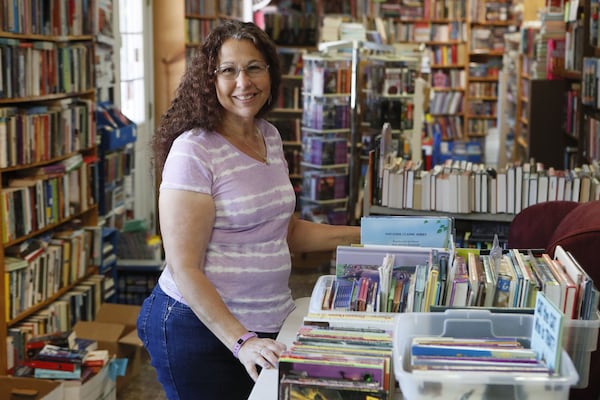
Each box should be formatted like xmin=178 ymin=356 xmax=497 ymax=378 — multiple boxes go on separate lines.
xmin=138 ymin=21 xmax=360 ymax=400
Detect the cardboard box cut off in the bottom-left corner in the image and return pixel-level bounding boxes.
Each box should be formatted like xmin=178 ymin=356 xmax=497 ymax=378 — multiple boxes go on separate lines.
xmin=0 ymin=376 xmax=64 ymax=400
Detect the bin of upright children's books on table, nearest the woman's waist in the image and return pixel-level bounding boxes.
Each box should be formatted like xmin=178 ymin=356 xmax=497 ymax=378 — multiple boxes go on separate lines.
xmin=309 ymin=245 xmax=450 ymax=326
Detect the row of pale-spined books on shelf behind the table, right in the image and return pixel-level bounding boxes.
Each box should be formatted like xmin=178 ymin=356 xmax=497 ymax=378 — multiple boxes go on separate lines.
xmin=371 ymin=158 xmax=600 ymax=214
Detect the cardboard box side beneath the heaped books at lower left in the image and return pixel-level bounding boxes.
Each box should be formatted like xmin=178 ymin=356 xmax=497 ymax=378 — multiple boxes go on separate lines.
xmin=63 ymin=364 xmax=117 ymax=400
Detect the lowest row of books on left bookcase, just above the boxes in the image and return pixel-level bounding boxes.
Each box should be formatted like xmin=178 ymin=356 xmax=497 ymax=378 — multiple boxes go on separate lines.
xmin=6 ymin=275 xmax=114 ymax=372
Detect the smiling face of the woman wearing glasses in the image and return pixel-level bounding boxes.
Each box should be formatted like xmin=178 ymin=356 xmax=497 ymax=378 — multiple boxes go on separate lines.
xmin=215 ymin=39 xmax=271 ymax=124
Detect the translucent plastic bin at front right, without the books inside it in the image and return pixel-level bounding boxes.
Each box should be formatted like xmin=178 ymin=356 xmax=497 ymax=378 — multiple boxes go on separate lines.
xmin=393 ymin=310 xmax=579 ymax=400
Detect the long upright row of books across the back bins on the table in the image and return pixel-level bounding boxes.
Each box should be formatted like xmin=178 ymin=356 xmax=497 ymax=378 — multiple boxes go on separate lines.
xmin=314 ymin=241 xmax=600 ymax=320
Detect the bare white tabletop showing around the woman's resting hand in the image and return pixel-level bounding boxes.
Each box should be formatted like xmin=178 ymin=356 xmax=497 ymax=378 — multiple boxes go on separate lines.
xmin=248 ymin=297 xmax=402 ymax=400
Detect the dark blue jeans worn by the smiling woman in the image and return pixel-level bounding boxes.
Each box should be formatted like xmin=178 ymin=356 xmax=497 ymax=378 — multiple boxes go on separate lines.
xmin=137 ymin=285 xmax=275 ymax=400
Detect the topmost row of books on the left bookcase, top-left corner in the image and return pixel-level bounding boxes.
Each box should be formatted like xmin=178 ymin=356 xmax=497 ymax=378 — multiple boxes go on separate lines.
xmin=0 ymin=0 xmax=98 ymax=36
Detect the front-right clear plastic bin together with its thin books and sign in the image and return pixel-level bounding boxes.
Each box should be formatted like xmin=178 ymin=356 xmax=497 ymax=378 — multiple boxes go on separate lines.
xmin=393 ymin=310 xmax=579 ymax=400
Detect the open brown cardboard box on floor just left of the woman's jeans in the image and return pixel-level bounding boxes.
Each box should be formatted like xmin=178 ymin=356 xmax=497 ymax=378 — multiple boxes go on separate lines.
xmin=73 ymin=303 xmax=144 ymax=391
